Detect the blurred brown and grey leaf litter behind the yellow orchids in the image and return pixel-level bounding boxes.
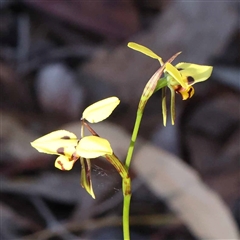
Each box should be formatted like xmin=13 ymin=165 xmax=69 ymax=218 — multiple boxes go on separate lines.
xmin=0 ymin=0 xmax=240 ymax=240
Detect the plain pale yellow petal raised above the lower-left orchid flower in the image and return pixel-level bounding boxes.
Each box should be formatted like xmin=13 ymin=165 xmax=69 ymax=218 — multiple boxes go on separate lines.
xmin=82 ymin=97 xmax=120 ymax=123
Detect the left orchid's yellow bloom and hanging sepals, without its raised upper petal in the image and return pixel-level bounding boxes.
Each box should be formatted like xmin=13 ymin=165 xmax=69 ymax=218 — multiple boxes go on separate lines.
xmin=31 ymin=130 xmax=113 ymax=198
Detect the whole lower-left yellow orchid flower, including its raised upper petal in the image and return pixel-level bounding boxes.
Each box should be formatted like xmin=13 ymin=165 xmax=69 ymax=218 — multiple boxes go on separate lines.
xmin=31 ymin=97 xmax=120 ymax=198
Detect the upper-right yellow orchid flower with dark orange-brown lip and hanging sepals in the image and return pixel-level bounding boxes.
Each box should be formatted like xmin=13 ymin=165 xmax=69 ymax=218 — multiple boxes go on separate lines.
xmin=128 ymin=42 xmax=213 ymax=126
